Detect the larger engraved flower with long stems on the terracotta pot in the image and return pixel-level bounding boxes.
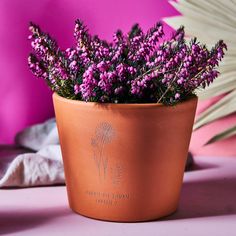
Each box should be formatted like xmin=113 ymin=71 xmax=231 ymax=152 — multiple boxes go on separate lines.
xmin=91 ymin=122 xmax=115 ymax=179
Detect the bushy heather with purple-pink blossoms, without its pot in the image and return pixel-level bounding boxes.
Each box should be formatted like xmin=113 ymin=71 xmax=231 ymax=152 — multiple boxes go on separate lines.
xmin=28 ymin=20 xmax=227 ymax=105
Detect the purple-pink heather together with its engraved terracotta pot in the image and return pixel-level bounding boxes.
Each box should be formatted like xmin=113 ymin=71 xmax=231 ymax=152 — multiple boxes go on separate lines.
xmin=28 ymin=20 xmax=226 ymax=222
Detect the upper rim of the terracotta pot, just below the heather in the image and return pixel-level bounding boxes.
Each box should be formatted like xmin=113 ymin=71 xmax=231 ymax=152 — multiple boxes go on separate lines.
xmin=52 ymin=92 xmax=198 ymax=108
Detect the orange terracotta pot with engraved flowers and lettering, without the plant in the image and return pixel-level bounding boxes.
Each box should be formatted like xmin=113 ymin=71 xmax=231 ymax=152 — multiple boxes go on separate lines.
xmin=53 ymin=93 xmax=197 ymax=222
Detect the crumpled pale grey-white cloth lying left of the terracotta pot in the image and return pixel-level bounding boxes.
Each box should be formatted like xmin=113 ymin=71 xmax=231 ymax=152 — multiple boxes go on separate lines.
xmin=0 ymin=119 xmax=65 ymax=188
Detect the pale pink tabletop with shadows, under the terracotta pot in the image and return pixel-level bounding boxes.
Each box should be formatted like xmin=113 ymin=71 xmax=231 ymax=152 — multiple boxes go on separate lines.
xmin=0 ymin=157 xmax=236 ymax=236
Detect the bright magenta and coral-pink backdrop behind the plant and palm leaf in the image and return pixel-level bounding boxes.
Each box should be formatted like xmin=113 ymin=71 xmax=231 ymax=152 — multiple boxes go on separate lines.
xmin=0 ymin=0 xmax=236 ymax=155
